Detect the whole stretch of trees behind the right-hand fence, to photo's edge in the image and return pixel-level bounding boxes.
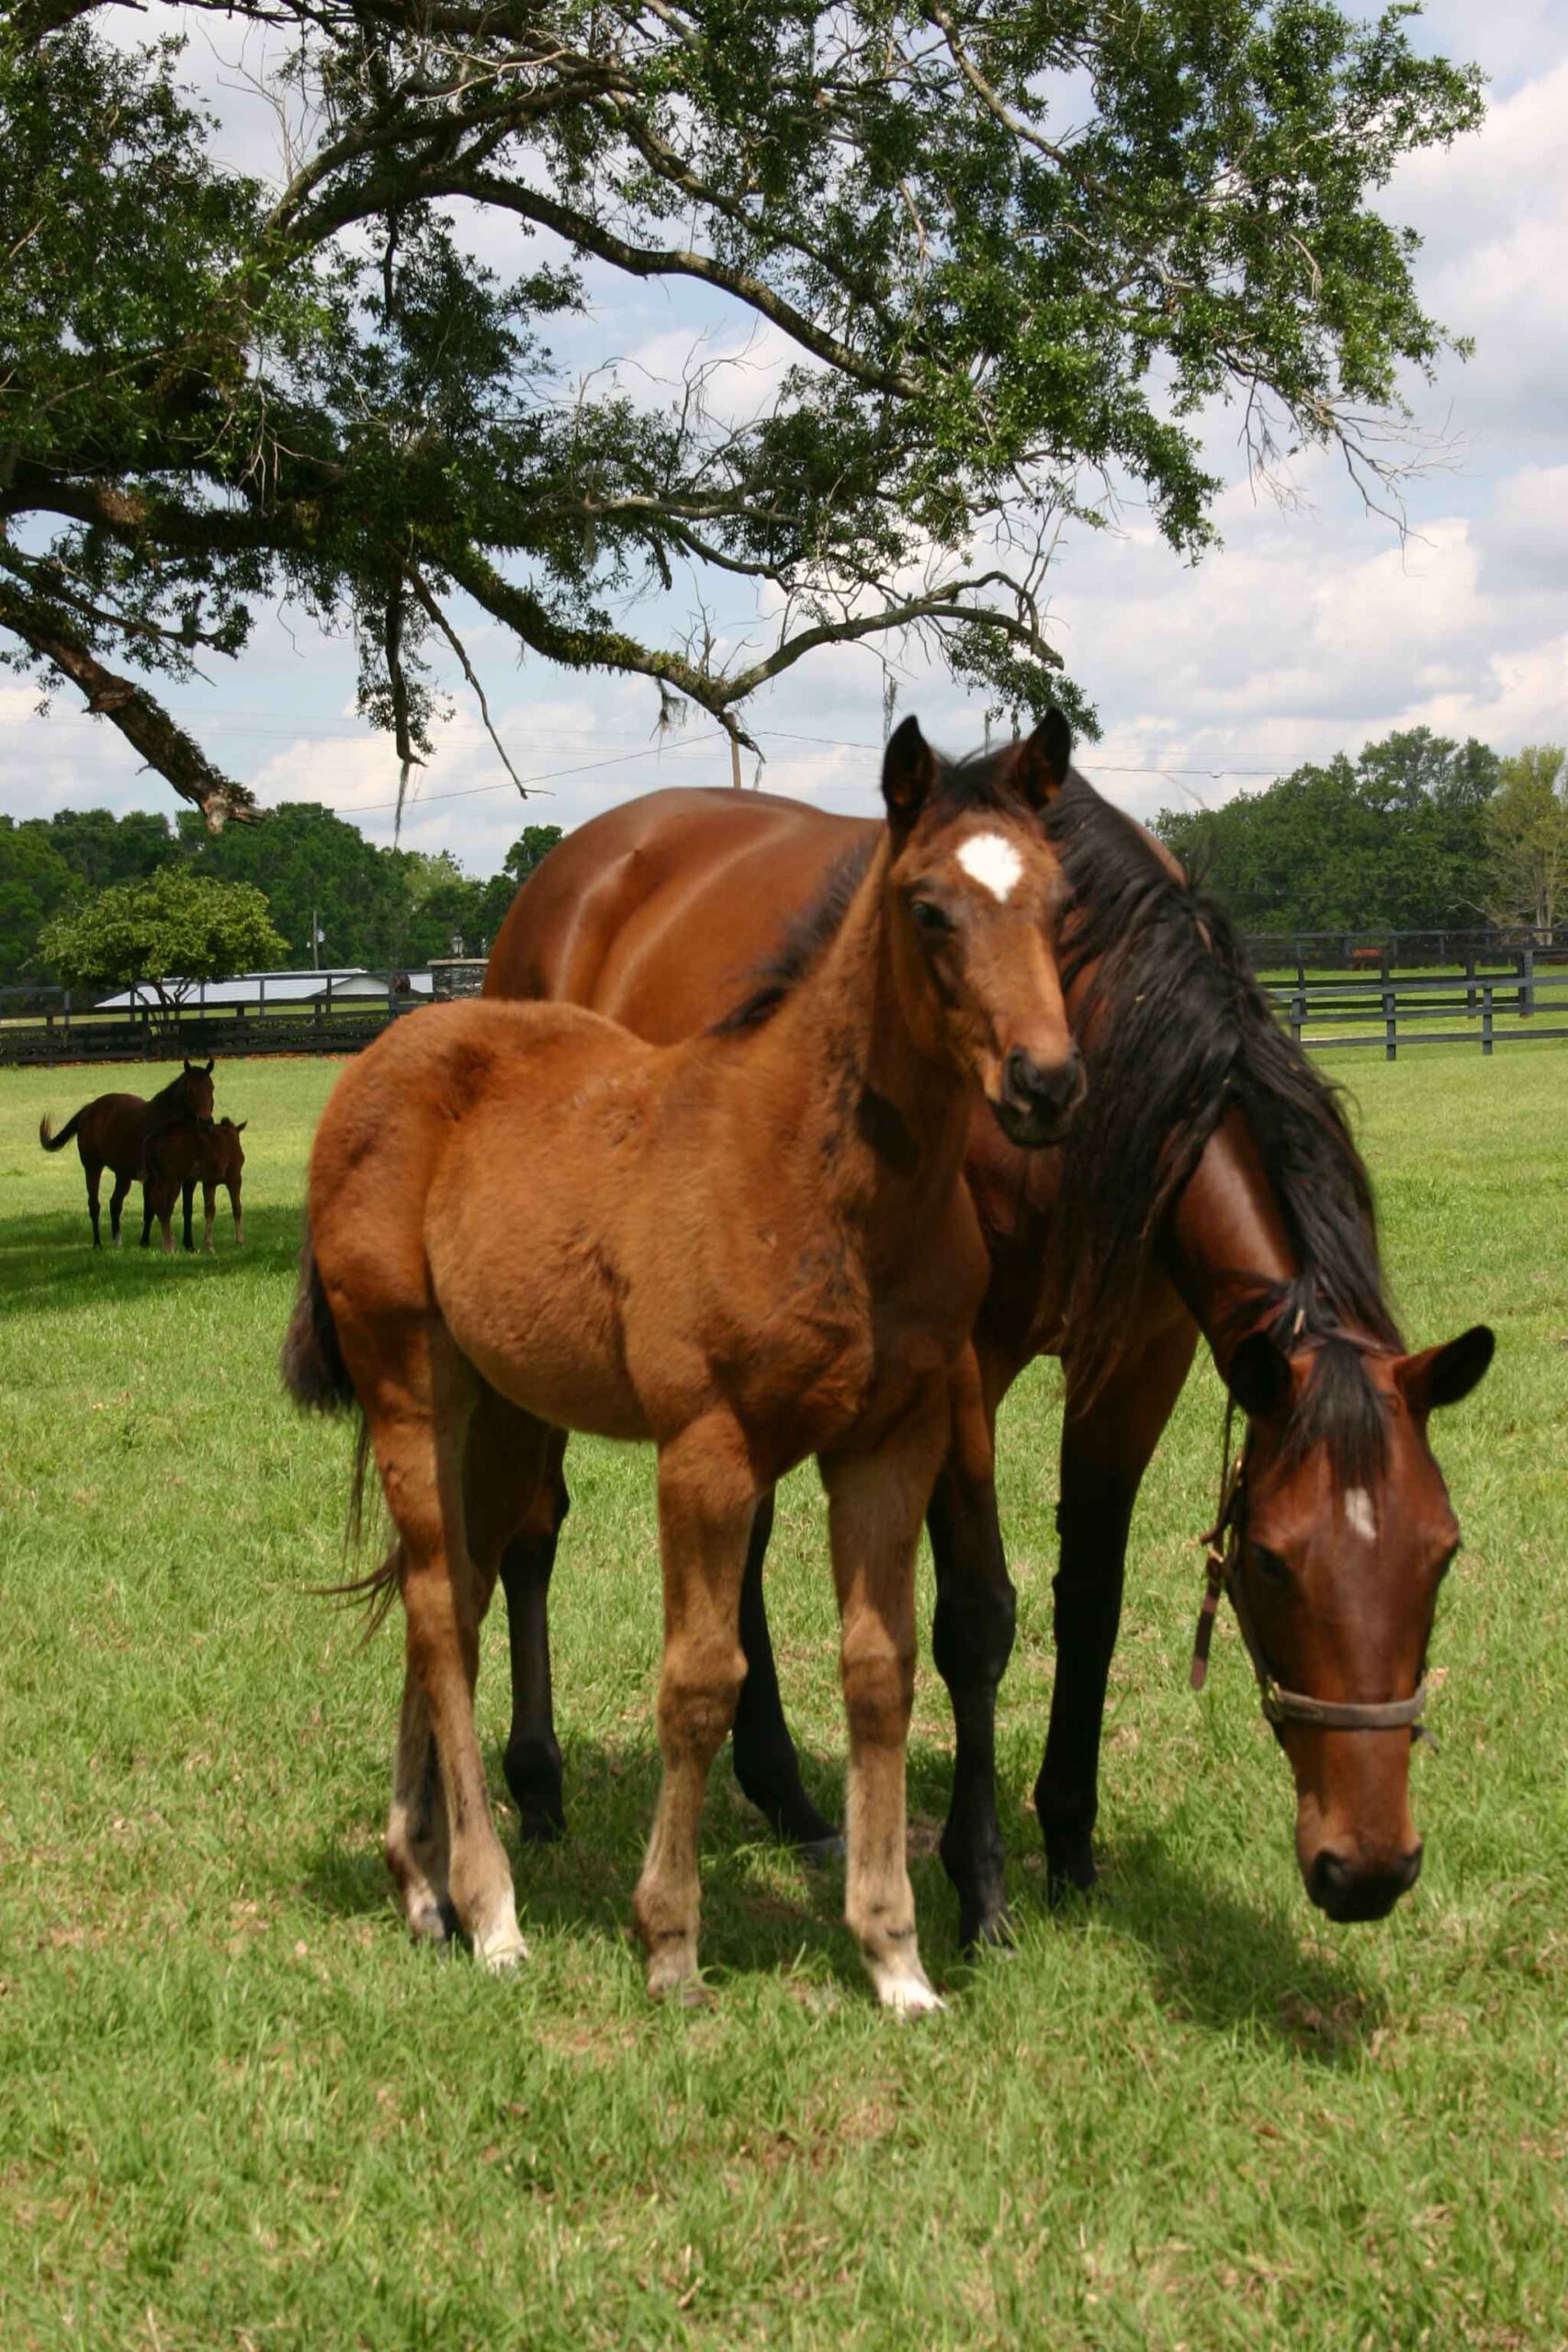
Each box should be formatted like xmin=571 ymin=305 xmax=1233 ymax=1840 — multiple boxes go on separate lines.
xmin=1155 ymin=727 xmax=1568 ymax=932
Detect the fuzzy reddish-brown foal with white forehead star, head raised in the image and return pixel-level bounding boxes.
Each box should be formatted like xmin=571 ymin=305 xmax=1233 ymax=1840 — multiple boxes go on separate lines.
xmin=285 ymin=719 xmax=1081 ymax=2008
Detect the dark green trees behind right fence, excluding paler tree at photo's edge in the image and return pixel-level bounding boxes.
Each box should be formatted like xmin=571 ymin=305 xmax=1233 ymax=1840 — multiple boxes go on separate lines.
xmin=1155 ymin=727 xmax=1497 ymax=932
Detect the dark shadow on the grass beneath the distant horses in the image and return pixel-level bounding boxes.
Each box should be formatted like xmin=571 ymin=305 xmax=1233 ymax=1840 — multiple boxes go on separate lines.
xmin=0 ymin=1190 xmax=299 ymax=1315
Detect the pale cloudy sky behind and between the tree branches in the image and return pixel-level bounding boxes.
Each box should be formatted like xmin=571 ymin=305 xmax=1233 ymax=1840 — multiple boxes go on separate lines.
xmin=0 ymin=0 xmax=1568 ymax=873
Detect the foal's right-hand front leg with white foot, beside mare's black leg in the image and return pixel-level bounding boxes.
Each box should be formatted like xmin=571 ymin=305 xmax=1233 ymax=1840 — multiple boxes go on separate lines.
xmin=823 ymin=1381 xmax=950 ymax=2013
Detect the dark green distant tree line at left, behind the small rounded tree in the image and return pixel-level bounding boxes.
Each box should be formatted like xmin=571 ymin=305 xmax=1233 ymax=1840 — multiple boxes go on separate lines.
xmin=0 ymin=799 xmax=559 ymax=983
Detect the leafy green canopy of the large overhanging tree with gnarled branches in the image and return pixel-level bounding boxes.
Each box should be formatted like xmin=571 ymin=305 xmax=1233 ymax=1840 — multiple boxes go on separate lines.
xmin=0 ymin=0 xmax=1481 ymax=826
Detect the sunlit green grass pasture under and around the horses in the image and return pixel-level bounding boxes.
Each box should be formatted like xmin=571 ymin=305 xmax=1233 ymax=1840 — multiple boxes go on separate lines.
xmin=0 ymin=1046 xmax=1568 ymax=2352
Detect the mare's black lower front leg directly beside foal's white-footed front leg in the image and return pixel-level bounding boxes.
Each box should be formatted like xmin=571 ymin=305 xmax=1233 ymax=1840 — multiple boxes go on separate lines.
xmin=926 ymin=1461 xmax=1018 ymax=1948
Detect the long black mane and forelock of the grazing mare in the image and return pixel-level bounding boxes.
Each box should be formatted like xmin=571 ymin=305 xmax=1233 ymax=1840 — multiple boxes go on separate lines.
xmin=1046 ymin=772 xmax=1399 ymax=1482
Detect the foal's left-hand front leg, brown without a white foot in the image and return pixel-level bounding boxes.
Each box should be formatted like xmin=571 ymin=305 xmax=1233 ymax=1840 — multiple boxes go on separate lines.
xmin=635 ymin=1414 xmax=757 ymax=1999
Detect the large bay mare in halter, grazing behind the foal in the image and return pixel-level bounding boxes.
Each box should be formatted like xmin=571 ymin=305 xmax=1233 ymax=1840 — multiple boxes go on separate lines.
xmin=484 ymin=738 xmax=1493 ymax=1943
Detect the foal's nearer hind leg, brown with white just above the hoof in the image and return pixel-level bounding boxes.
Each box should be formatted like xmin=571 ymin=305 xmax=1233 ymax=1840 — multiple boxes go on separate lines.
xmin=355 ymin=1317 xmax=525 ymax=1969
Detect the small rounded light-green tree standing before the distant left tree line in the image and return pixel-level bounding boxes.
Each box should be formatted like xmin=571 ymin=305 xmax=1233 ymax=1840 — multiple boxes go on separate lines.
xmin=40 ymin=865 xmax=285 ymax=1004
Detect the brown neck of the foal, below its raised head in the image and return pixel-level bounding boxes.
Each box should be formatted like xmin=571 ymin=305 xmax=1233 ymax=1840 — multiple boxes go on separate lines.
xmin=760 ymin=832 xmax=974 ymax=1211
